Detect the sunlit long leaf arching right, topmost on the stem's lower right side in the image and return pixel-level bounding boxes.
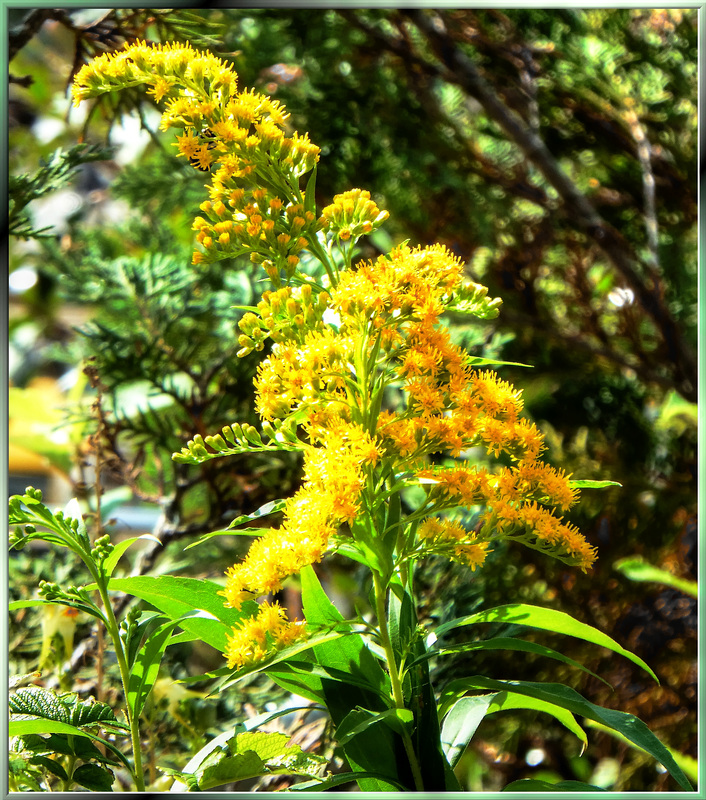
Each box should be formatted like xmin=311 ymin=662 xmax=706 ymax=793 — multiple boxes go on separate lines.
xmin=427 ymin=603 xmax=659 ymax=683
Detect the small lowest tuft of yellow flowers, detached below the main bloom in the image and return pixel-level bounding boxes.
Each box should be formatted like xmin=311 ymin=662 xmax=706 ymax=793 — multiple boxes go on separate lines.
xmin=226 ymin=601 xmax=307 ymax=669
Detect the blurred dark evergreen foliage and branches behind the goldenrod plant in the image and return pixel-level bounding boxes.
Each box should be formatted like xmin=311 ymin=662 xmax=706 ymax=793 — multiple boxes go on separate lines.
xmin=9 ymin=8 xmax=698 ymax=791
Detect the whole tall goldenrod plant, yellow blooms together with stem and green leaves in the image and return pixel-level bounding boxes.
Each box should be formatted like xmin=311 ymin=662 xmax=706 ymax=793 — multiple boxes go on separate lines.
xmin=8 ymin=42 xmax=691 ymax=792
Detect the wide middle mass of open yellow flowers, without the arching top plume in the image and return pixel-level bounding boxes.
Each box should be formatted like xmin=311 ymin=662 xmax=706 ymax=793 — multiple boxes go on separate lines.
xmin=226 ymin=238 xmax=595 ymax=624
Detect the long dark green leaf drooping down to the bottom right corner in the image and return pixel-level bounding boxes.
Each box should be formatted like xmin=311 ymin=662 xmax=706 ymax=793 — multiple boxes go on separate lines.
xmin=452 ymin=675 xmax=693 ymax=792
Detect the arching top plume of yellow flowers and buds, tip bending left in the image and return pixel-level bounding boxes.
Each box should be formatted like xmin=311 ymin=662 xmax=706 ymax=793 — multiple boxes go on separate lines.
xmin=73 ymin=42 xmax=319 ymax=272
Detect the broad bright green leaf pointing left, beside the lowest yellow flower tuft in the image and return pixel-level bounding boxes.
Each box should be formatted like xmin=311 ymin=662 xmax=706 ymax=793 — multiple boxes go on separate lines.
xmin=103 ymin=575 xmax=257 ymax=653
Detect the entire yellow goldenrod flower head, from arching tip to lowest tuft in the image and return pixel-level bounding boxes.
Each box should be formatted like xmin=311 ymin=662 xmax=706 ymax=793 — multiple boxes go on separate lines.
xmin=73 ymin=42 xmax=595 ymax=667
